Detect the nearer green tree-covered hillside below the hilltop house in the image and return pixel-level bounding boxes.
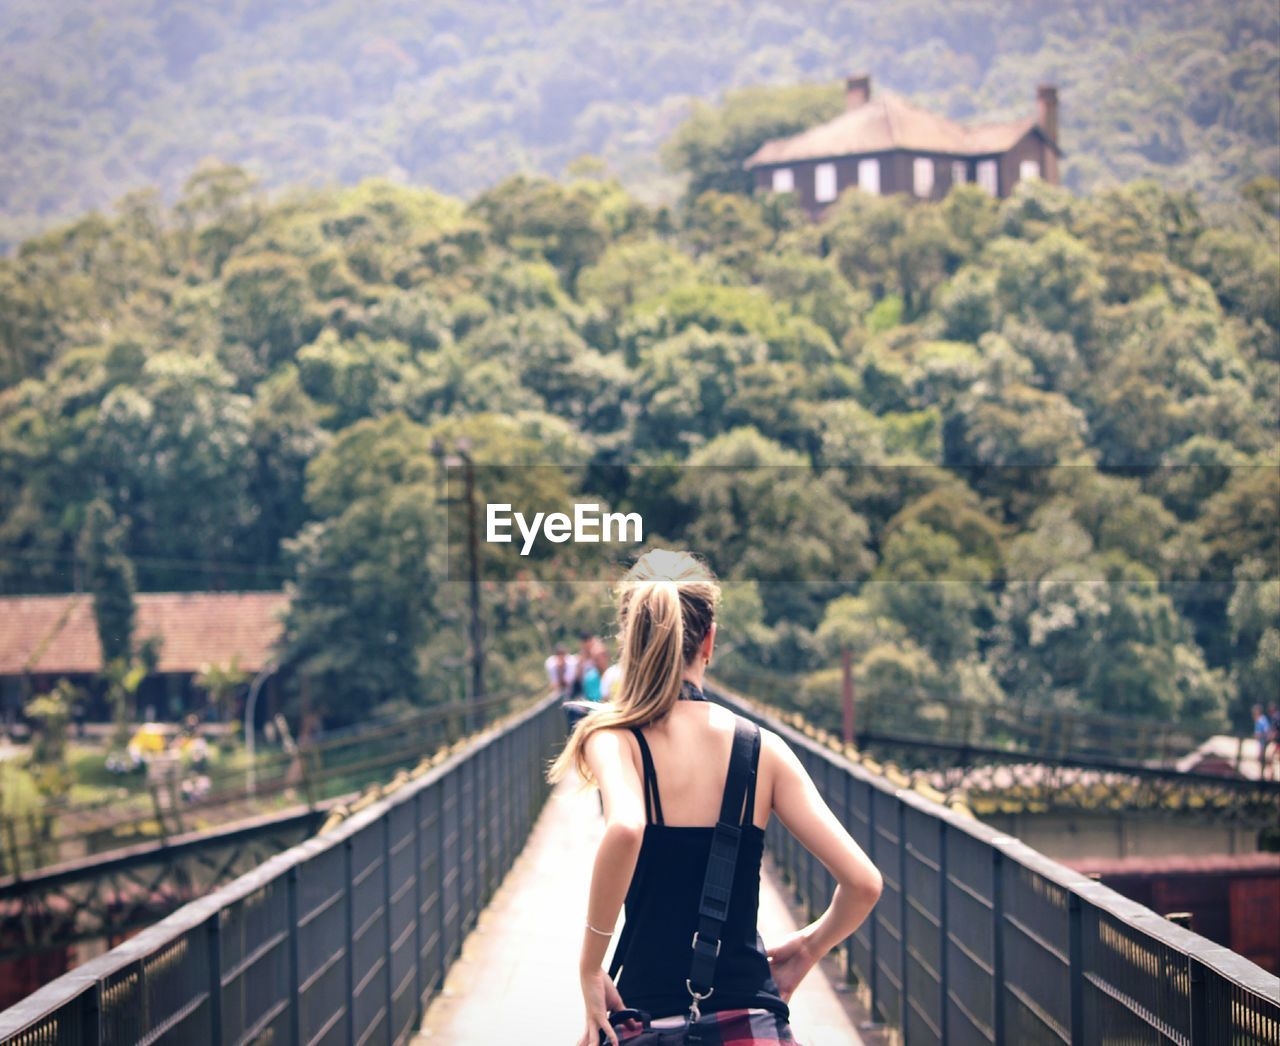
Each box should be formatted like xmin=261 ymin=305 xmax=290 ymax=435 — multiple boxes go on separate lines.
xmin=0 ymin=124 xmax=1280 ymax=728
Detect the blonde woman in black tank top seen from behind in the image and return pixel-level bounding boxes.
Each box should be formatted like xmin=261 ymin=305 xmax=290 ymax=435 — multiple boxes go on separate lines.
xmin=550 ymin=549 xmax=881 ymax=1046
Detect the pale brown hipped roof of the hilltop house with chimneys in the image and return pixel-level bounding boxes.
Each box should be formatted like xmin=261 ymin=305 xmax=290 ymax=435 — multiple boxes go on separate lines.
xmin=744 ymin=93 xmax=1057 ymax=169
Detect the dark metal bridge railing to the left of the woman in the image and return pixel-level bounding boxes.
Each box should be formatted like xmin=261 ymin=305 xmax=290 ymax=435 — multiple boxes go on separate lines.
xmin=0 ymin=698 xmax=564 ymax=1046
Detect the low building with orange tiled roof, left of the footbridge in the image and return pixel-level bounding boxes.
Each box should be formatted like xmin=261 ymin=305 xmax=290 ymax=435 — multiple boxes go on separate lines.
xmin=0 ymin=591 xmax=288 ymax=726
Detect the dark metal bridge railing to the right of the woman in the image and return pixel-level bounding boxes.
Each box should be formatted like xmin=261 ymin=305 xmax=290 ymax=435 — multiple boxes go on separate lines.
xmin=716 ymin=691 xmax=1280 ymax=1046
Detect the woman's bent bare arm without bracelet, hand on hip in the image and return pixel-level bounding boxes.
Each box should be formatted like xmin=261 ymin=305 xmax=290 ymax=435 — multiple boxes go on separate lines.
xmin=760 ymin=728 xmax=883 ymax=1001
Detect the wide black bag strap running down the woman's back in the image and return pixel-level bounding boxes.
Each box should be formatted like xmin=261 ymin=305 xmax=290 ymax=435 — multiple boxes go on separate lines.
xmin=689 ymin=716 xmax=760 ymax=999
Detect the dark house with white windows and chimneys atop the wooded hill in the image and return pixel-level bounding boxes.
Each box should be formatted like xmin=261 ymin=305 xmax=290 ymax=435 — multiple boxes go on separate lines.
xmin=744 ymin=76 xmax=1062 ymax=218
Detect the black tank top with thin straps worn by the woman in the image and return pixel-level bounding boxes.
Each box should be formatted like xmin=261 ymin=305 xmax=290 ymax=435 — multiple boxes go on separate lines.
xmin=609 ymin=723 xmax=791 ymax=1020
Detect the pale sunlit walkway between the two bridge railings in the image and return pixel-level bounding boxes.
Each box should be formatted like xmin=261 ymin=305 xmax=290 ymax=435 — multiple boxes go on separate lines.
xmin=412 ymin=782 xmax=861 ymax=1046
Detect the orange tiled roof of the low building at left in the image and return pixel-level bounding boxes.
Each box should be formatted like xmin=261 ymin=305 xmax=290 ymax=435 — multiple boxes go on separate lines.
xmin=0 ymin=591 xmax=288 ymax=676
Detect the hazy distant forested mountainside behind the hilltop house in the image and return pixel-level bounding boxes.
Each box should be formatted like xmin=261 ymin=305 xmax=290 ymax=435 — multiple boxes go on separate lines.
xmin=0 ymin=0 xmax=1280 ymax=251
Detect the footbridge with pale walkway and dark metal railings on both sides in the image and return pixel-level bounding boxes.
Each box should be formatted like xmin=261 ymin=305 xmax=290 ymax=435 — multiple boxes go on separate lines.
xmin=0 ymin=693 xmax=1280 ymax=1046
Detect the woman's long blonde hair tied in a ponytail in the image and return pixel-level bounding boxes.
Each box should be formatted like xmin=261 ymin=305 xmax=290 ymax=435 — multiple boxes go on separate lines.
xmin=547 ymin=548 xmax=721 ymax=785
